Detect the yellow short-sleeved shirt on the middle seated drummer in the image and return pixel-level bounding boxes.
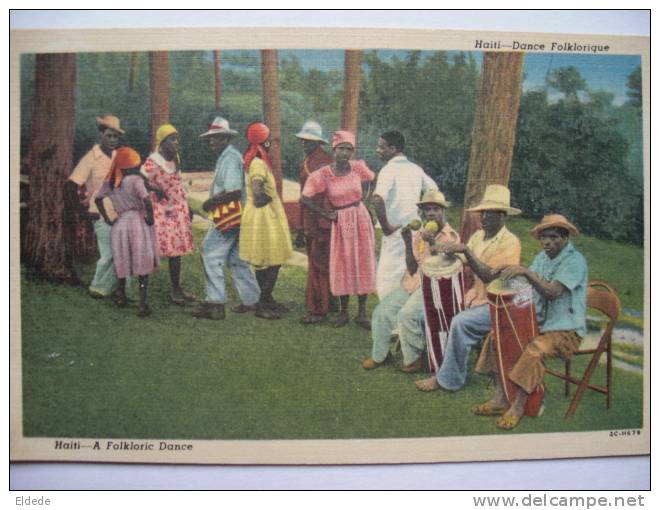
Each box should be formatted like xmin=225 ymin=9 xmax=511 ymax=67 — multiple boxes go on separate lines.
xmin=460 ymin=227 xmax=521 ymax=308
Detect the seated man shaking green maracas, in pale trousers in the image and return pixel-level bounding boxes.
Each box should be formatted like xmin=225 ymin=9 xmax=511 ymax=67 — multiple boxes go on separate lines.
xmin=362 ymin=190 xmax=460 ymax=373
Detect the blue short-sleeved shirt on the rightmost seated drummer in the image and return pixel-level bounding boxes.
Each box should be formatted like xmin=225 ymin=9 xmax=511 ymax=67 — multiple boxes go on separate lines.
xmin=529 ymin=241 xmax=588 ymax=337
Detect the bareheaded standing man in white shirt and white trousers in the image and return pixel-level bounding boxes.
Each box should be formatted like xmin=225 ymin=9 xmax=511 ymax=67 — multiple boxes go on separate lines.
xmin=372 ymin=131 xmax=438 ymax=299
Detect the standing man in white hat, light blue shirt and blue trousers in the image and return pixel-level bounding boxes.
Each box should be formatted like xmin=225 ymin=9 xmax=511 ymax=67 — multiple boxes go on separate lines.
xmin=193 ymin=117 xmax=259 ymax=320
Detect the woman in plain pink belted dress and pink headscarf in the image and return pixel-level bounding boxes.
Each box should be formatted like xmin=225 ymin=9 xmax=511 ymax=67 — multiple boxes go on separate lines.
xmin=301 ymin=131 xmax=376 ymax=329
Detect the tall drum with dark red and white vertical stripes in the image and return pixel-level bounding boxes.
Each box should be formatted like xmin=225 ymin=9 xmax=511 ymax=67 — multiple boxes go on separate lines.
xmin=420 ymin=254 xmax=465 ymax=372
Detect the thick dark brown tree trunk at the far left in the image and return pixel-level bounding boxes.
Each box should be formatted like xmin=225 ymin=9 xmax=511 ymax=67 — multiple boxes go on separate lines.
xmin=22 ymin=54 xmax=79 ymax=283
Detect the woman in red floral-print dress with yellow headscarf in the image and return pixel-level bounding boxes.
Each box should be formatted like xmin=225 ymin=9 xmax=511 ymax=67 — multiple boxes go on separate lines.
xmin=142 ymin=124 xmax=195 ymax=305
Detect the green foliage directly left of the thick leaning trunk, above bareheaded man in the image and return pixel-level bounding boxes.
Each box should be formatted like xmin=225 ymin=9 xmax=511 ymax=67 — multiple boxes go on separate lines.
xmin=360 ymin=51 xmax=479 ymax=201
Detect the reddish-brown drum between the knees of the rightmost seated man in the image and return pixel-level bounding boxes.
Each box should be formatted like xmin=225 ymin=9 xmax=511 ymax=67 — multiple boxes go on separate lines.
xmin=487 ymin=277 xmax=543 ymax=416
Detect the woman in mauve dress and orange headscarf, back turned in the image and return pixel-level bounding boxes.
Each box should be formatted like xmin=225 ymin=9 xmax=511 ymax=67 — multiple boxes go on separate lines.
xmin=95 ymin=147 xmax=160 ymax=317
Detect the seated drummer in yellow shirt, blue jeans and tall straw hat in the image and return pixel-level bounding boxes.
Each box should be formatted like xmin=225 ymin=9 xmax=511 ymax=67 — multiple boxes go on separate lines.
xmin=415 ymin=184 xmax=520 ymax=391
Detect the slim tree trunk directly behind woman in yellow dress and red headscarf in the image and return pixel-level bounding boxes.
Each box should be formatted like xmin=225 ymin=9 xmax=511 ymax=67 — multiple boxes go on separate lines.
xmin=261 ymin=50 xmax=282 ymax=198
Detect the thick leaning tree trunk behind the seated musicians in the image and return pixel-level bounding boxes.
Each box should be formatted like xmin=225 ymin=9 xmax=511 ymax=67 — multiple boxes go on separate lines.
xmin=461 ymin=52 xmax=523 ymax=242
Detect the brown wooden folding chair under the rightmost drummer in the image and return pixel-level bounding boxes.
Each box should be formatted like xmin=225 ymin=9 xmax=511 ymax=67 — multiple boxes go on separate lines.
xmin=546 ymin=280 xmax=621 ymax=420
